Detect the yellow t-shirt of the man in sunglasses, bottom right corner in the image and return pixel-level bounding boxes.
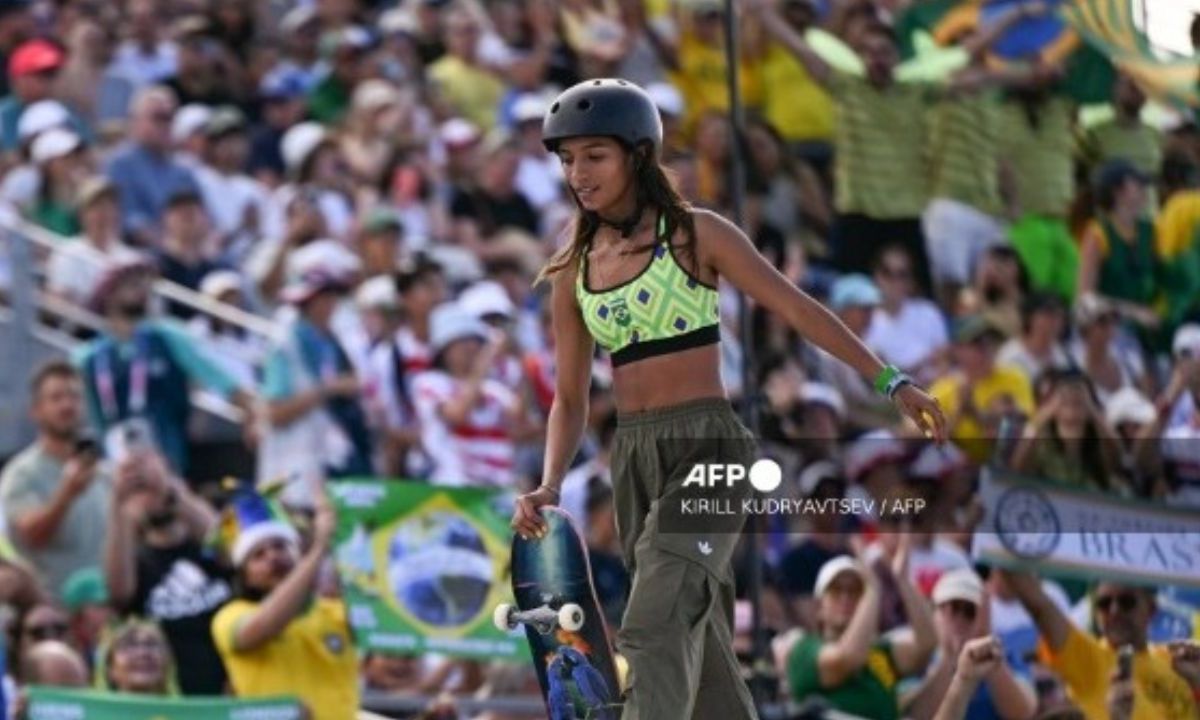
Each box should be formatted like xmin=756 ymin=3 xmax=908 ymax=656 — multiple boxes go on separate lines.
xmin=1038 ymin=628 xmax=1196 ymax=720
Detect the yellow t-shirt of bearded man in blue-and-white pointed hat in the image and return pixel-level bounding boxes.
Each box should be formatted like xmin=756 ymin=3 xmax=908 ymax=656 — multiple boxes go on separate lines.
xmin=211 ymin=598 xmax=359 ymax=720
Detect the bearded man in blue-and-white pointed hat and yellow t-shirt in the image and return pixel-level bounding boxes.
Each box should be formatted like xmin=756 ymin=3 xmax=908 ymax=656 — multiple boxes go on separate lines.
xmin=212 ymin=488 xmax=359 ymax=720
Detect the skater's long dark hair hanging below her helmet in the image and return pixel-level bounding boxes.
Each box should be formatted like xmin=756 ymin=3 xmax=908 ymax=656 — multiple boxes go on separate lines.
xmin=534 ymin=143 xmax=696 ymax=286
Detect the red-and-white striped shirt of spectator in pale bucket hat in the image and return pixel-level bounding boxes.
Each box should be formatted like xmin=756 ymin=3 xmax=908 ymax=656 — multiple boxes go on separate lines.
xmin=413 ymin=370 xmax=517 ymax=487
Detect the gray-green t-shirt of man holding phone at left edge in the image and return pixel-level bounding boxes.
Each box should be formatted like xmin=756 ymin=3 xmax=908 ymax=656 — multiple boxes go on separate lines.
xmin=0 ymin=443 xmax=110 ymax=595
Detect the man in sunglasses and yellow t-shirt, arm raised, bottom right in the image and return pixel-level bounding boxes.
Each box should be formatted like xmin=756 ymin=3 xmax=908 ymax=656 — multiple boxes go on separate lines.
xmin=1001 ymin=571 xmax=1200 ymax=720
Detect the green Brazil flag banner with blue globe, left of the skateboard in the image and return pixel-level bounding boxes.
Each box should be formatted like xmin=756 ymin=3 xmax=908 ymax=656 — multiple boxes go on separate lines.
xmin=329 ymin=480 xmax=529 ymax=660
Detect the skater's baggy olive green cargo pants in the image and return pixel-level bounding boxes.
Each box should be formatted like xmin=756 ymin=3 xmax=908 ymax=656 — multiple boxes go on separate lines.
xmin=612 ymin=398 xmax=757 ymax=720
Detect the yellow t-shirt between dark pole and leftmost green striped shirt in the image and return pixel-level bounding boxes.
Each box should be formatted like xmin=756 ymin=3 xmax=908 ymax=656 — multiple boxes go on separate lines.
xmin=762 ymin=44 xmax=833 ymax=142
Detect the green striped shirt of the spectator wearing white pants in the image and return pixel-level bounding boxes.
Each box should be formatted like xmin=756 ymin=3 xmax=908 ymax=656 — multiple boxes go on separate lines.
xmin=929 ymin=92 xmax=1002 ymax=215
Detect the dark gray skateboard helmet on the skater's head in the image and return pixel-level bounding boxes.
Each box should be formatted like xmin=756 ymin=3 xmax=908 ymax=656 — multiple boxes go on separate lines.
xmin=541 ymin=78 xmax=662 ymax=154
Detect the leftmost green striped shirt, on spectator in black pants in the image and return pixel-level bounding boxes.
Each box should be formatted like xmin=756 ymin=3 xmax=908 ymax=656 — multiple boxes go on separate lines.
xmin=829 ymin=70 xmax=935 ymax=220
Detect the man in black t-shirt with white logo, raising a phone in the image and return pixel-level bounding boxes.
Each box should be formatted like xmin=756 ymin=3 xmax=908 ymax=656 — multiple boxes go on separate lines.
xmin=104 ymin=452 xmax=233 ymax=695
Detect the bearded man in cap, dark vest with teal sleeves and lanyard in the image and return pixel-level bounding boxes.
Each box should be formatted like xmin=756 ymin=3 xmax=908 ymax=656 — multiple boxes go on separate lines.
xmin=77 ymin=258 xmax=253 ymax=477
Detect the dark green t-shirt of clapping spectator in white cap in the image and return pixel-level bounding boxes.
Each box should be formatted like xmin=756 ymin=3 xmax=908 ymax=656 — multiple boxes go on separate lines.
xmin=787 ymin=635 xmax=900 ymax=720
